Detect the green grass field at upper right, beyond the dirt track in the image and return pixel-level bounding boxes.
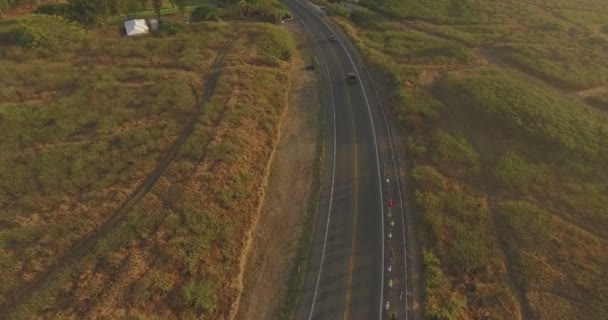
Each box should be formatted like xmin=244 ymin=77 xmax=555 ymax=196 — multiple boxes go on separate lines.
xmin=354 ymin=0 xmax=608 ymax=89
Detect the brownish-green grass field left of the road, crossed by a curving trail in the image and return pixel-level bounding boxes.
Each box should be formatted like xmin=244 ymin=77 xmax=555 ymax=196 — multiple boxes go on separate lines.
xmin=0 ymin=14 xmax=294 ymax=319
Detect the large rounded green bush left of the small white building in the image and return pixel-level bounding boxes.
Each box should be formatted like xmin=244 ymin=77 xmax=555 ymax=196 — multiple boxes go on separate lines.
xmin=12 ymin=15 xmax=86 ymax=49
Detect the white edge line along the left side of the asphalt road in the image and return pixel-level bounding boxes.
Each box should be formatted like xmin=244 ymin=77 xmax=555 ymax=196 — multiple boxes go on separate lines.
xmin=292 ymin=7 xmax=336 ymax=320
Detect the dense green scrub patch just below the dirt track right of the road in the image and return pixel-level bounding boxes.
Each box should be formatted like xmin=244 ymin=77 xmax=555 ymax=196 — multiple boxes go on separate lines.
xmin=441 ymin=74 xmax=608 ymax=161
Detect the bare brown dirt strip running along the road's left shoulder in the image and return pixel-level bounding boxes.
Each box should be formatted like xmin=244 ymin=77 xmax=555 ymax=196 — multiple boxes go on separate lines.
xmin=236 ymin=23 xmax=321 ymax=319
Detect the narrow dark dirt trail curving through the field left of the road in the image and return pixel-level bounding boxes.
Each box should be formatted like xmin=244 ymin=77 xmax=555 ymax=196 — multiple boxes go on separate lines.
xmin=0 ymin=38 xmax=236 ymax=319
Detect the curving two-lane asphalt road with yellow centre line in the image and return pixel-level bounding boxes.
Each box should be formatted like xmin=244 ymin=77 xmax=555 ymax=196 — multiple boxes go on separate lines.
xmin=284 ymin=0 xmax=414 ymax=319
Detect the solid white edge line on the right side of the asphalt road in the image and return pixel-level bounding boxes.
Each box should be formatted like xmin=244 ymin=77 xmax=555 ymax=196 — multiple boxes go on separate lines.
xmin=288 ymin=0 xmax=385 ymax=319
